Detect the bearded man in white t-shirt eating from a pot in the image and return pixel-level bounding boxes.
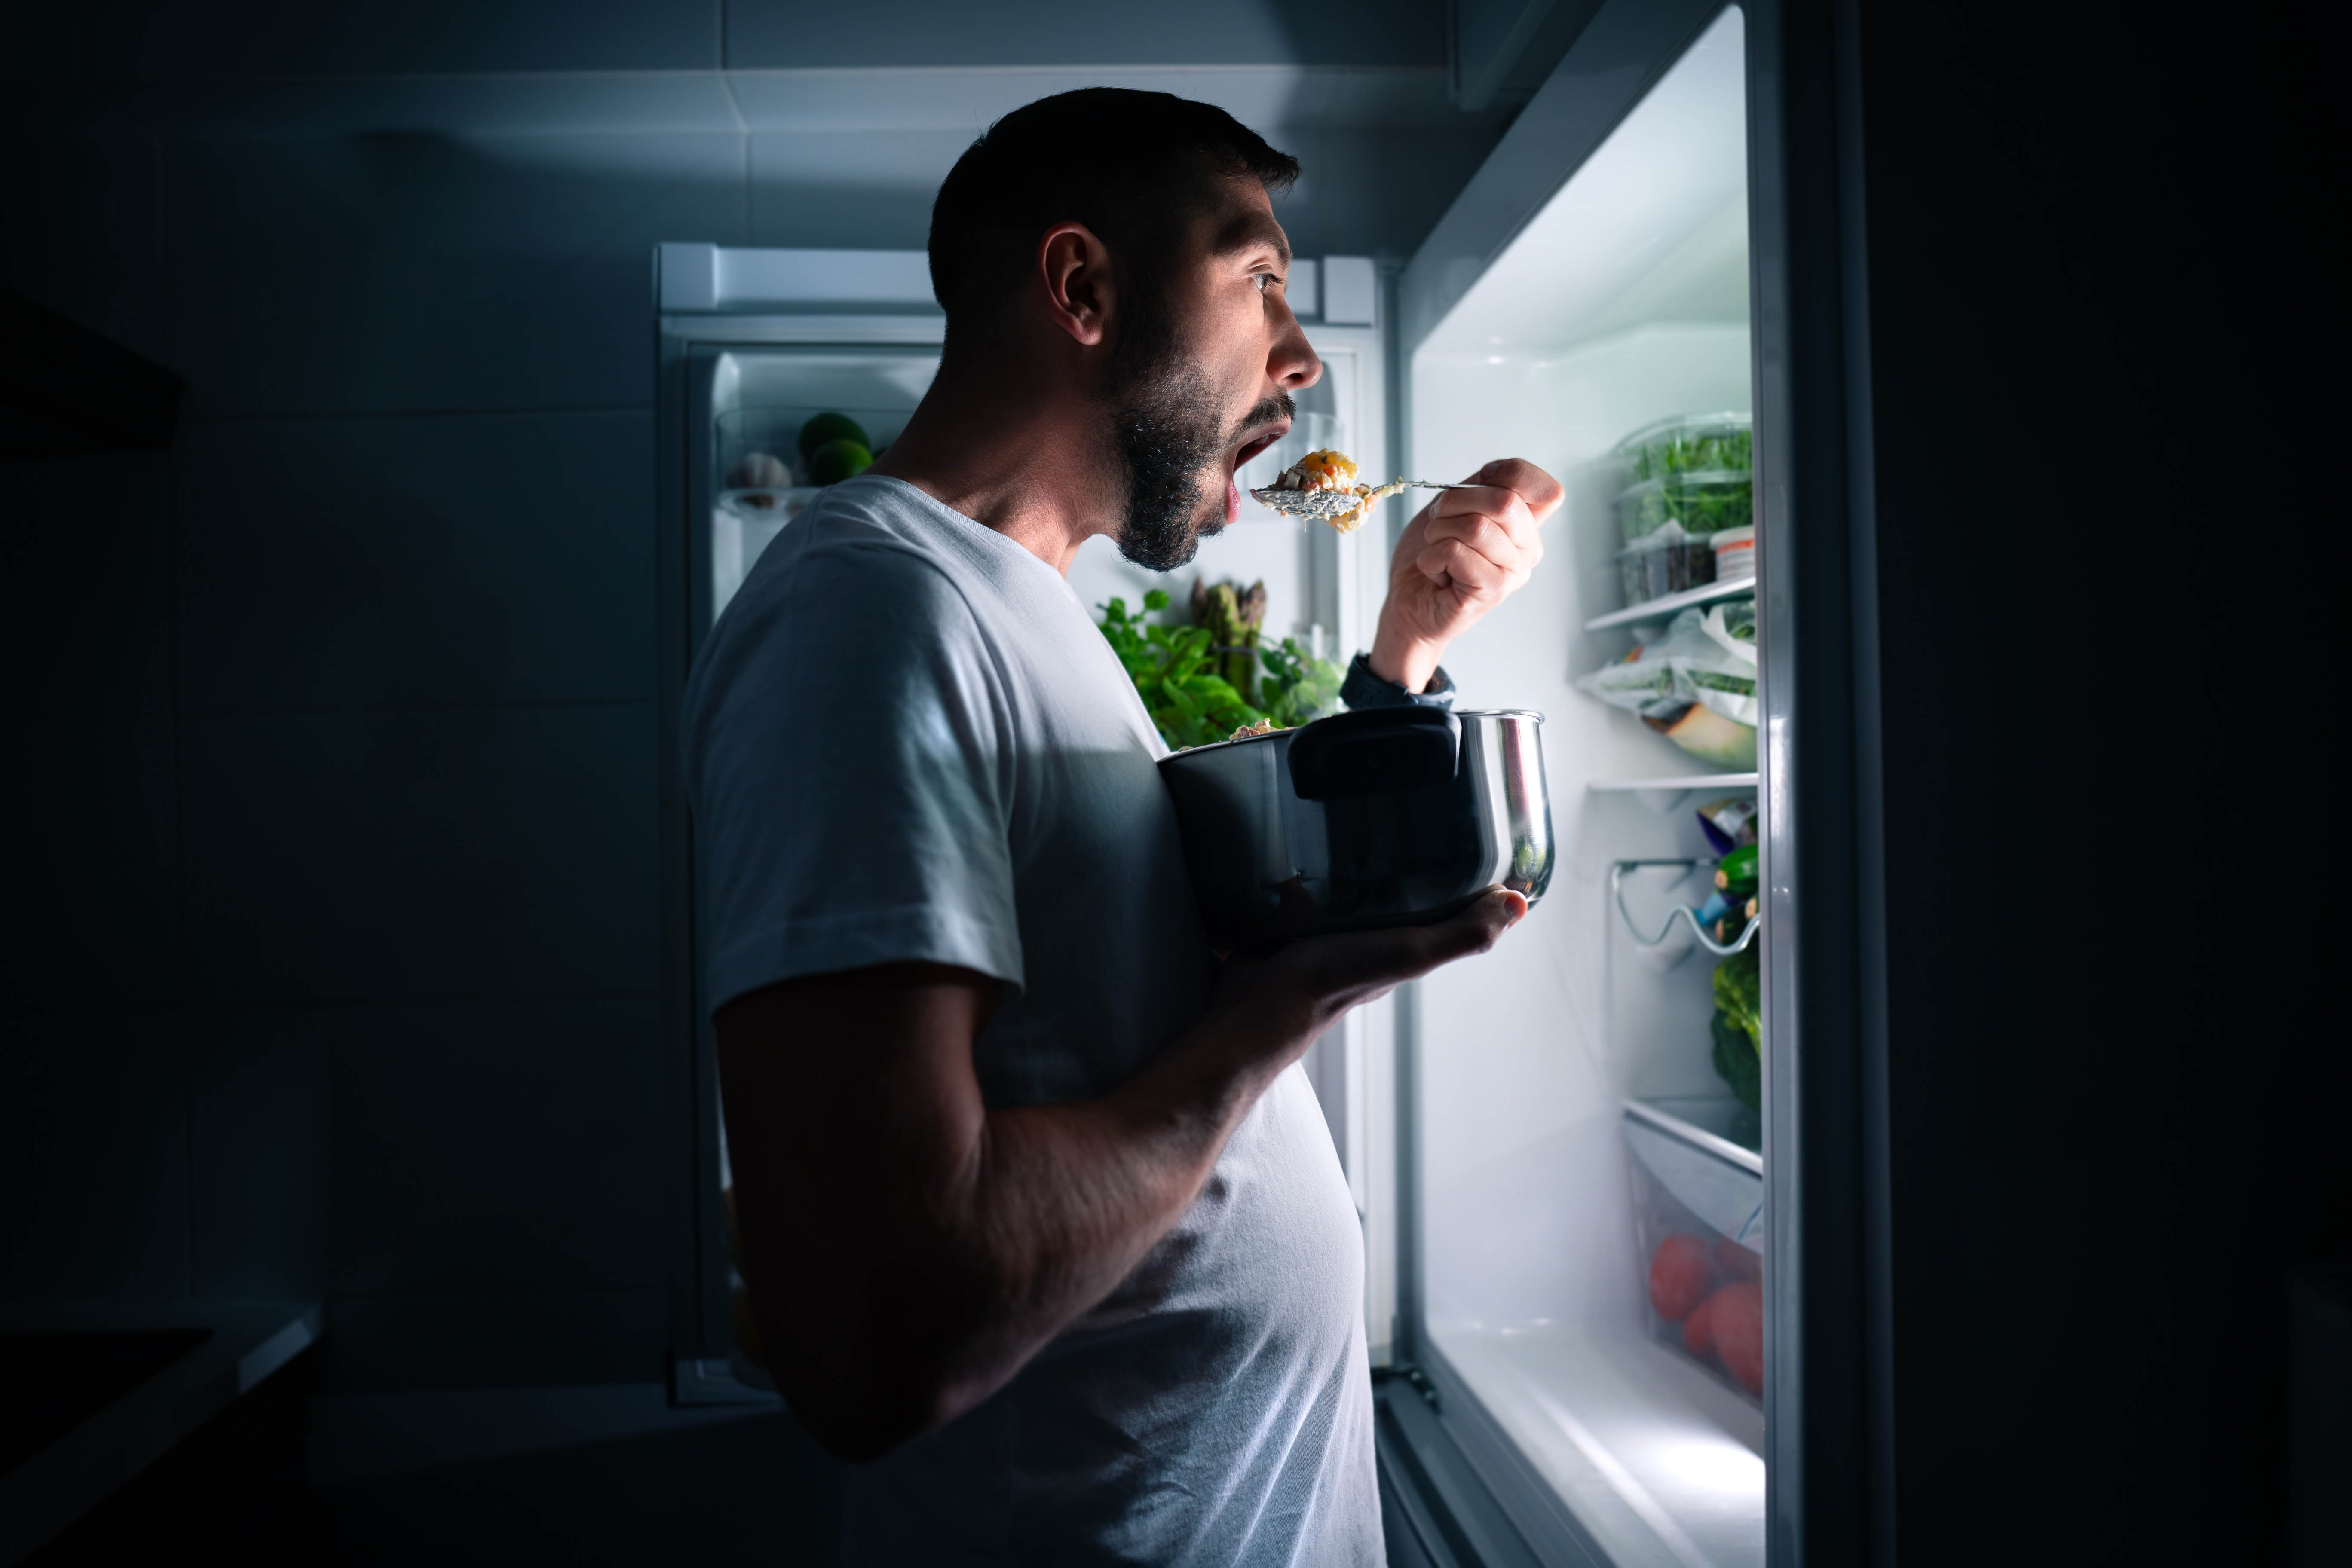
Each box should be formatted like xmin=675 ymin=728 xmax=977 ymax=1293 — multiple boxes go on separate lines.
xmin=687 ymin=89 xmax=1559 ymax=1563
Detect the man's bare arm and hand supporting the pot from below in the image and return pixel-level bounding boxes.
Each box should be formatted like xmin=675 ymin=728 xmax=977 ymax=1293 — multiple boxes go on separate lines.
xmin=715 ymin=891 xmax=1526 ymax=1460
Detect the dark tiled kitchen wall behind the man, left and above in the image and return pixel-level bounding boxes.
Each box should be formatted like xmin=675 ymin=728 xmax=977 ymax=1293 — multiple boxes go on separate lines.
xmin=0 ymin=0 xmax=1491 ymax=1387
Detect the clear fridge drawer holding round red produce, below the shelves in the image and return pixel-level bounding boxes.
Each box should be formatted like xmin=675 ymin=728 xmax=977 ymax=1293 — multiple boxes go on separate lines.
xmin=1625 ymin=1098 xmax=1764 ymax=1401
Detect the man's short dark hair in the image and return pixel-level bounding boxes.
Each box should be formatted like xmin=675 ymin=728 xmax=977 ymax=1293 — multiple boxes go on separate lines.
xmin=931 ymin=87 xmax=1298 ymax=352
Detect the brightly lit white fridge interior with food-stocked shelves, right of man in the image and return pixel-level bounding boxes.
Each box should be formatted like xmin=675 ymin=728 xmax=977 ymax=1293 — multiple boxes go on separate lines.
xmin=1390 ymin=2 xmax=1788 ymax=1568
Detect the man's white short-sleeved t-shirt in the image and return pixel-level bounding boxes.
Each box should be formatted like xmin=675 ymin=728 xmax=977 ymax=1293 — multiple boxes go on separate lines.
xmin=684 ymin=477 xmax=1383 ymax=1566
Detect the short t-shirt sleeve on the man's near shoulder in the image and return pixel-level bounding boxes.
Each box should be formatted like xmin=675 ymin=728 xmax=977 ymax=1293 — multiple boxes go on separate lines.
xmin=684 ymin=541 xmax=1023 ymax=1009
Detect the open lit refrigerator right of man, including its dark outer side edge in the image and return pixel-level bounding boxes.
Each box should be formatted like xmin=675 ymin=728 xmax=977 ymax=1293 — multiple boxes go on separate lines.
xmin=1376 ymin=0 xmax=1891 ymax=1568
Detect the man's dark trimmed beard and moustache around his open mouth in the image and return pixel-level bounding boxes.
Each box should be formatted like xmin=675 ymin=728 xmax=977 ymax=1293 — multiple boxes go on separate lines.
xmin=1108 ymin=301 xmax=1291 ymax=571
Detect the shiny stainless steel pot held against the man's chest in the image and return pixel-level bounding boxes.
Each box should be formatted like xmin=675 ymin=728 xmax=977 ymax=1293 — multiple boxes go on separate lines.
xmin=1160 ymin=708 xmax=1553 ymax=945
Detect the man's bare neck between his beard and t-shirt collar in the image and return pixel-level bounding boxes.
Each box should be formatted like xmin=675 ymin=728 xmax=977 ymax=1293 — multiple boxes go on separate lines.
xmin=873 ymin=364 xmax=1117 ymax=576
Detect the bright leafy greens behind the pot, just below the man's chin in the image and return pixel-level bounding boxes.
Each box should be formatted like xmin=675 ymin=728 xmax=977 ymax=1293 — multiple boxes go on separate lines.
xmin=1101 ymin=588 xmax=1341 ymax=748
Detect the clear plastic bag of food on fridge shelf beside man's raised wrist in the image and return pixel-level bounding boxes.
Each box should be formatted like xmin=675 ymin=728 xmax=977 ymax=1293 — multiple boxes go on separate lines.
xmin=1576 ymin=599 xmax=1757 ymax=773
